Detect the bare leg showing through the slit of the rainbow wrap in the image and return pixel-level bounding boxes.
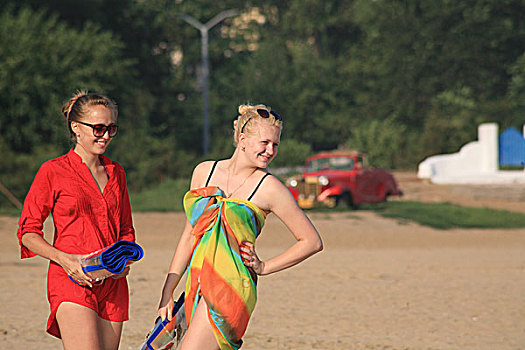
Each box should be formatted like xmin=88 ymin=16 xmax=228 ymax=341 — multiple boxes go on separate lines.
xmin=181 ymin=298 xmax=219 ymax=350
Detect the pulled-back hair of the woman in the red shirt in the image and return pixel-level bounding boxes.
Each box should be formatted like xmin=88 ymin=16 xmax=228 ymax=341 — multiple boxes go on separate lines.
xmin=62 ymin=90 xmax=118 ymax=142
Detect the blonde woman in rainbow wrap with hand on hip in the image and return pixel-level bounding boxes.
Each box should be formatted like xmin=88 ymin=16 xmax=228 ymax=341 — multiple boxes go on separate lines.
xmin=158 ymin=105 xmax=323 ymax=350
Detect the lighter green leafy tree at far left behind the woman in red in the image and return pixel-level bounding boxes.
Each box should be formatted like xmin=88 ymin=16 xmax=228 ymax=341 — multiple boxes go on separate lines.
xmin=0 ymin=8 xmax=132 ymax=205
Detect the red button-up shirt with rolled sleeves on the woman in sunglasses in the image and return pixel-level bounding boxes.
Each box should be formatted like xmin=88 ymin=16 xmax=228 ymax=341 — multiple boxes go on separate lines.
xmin=17 ymin=150 xmax=135 ymax=258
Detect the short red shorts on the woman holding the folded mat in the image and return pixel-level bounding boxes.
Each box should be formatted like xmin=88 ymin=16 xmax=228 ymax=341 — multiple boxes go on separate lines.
xmin=47 ymin=263 xmax=129 ymax=338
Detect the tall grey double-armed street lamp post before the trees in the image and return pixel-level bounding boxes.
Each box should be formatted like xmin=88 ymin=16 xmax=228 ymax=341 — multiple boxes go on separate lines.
xmin=180 ymin=10 xmax=239 ymax=154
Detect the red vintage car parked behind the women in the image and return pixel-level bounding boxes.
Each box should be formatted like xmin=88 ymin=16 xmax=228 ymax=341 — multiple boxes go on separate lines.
xmin=286 ymin=151 xmax=402 ymax=208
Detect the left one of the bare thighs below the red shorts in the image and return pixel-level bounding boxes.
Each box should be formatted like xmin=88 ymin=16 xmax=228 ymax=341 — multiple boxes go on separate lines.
xmin=56 ymin=302 xmax=102 ymax=350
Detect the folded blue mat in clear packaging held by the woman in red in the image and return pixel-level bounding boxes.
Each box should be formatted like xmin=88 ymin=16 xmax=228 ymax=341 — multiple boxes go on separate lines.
xmin=70 ymin=241 xmax=144 ymax=282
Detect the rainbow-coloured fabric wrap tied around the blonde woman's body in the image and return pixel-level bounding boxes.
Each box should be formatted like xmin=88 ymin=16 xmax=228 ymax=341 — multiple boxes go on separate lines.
xmin=184 ymin=186 xmax=266 ymax=350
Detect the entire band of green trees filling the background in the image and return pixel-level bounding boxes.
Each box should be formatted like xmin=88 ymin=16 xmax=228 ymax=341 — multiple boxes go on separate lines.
xmin=0 ymin=0 xmax=525 ymax=208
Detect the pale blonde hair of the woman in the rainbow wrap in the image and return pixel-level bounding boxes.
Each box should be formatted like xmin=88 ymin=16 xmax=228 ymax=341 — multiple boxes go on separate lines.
xmin=233 ymin=105 xmax=283 ymax=147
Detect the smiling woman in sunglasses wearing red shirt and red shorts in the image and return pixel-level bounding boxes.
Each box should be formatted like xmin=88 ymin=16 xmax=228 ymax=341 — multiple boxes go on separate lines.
xmin=17 ymin=92 xmax=135 ymax=350
